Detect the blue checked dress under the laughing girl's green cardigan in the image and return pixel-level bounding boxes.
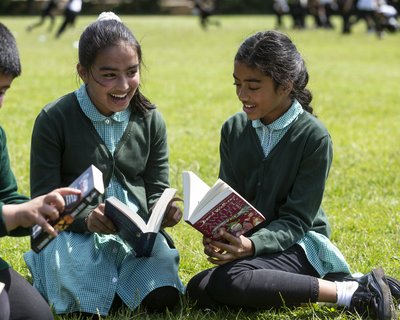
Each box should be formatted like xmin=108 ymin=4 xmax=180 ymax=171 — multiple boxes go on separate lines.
xmin=24 ymin=85 xmax=184 ymax=315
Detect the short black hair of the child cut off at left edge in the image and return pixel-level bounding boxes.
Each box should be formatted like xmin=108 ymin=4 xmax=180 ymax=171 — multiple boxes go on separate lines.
xmin=0 ymin=23 xmax=21 ymax=78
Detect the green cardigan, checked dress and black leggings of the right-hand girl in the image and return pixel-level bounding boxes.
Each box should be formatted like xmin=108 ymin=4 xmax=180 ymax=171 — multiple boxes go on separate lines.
xmin=188 ymin=101 xmax=350 ymax=308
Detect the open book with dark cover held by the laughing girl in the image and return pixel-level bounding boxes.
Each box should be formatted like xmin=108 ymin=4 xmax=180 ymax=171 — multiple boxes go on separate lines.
xmin=104 ymin=188 xmax=177 ymax=257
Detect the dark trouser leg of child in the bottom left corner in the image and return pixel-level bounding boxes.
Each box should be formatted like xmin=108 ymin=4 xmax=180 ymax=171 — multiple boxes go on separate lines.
xmin=0 ymin=268 xmax=54 ymax=320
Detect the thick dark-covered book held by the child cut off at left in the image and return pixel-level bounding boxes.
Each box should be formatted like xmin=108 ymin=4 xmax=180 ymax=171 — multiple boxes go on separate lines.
xmin=31 ymin=165 xmax=104 ymax=253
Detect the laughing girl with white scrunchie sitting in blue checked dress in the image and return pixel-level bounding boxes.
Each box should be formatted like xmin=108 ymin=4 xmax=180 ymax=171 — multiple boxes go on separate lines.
xmin=25 ymin=13 xmax=184 ymax=316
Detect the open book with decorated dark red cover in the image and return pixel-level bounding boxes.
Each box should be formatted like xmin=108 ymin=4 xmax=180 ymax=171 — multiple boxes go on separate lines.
xmin=182 ymin=171 xmax=265 ymax=241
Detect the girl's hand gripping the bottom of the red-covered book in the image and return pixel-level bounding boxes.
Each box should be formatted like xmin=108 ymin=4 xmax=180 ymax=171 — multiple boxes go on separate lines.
xmin=203 ymin=229 xmax=254 ymax=265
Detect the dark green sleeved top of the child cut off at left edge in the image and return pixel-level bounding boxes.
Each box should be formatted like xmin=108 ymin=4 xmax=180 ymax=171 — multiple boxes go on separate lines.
xmin=0 ymin=127 xmax=31 ymax=270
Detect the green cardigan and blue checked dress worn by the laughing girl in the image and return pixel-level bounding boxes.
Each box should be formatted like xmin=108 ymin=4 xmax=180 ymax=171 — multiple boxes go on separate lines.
xmin=24 ymin=85 xmax=184 ymax=315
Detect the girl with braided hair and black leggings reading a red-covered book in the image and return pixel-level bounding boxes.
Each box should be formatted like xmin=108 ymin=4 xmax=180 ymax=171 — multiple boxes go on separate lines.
xmin=187 ymin=31 xmax=395 ymax=319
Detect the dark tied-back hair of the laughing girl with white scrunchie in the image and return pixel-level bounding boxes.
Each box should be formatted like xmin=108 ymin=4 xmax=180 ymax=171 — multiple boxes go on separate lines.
xmin=79 ymin=19 xmax=155 ymax=114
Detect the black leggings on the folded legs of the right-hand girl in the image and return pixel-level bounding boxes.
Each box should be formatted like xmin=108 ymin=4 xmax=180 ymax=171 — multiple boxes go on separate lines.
xmin=187 ymin=245 xmax=340 ymax=309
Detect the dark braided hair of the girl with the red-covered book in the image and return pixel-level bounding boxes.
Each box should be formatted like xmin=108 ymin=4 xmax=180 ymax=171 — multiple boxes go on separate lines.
xmin=235 ymin=30 xmax=313 ymax=114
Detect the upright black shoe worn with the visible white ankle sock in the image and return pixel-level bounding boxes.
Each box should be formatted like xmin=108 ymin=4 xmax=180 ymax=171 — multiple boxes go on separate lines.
xmin=349 ymin=268 xmax=396 ymax=320
